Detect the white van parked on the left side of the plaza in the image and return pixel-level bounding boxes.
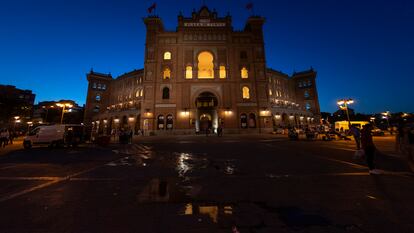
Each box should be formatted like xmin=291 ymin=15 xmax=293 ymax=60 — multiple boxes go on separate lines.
xmin=23 ymin=124 xmax=83 ymax=149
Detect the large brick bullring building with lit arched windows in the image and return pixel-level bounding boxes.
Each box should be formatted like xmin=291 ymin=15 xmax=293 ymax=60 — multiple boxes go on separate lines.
xmin=84 ymin=6 xmax=320 ymax=135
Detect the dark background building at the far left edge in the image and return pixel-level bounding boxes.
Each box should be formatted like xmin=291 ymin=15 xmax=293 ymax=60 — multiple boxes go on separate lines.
xmin=0 ymin=85 xmax=35 ymax=128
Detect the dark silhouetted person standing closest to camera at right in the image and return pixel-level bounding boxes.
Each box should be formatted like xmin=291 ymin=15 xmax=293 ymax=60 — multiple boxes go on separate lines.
xmin=361 ymin=124 xmax=381 ymax=175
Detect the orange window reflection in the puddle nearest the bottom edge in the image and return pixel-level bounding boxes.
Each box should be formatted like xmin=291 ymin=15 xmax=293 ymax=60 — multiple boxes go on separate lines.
xmin=181 ymin=203 xmax=233 ymax=223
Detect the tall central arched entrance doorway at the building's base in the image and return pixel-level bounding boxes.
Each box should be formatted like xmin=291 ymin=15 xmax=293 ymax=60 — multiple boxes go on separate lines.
xmin=195 ymin=92 xmax=218 ymax=132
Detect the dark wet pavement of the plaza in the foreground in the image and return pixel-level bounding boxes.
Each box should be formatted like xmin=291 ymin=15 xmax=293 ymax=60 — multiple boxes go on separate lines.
xmin=0 ymin=135 xmax=414 ymax=233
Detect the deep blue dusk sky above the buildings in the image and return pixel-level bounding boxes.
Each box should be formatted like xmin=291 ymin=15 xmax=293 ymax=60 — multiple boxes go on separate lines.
xmin=0 ymin=0 xmax=414 ymax=113
